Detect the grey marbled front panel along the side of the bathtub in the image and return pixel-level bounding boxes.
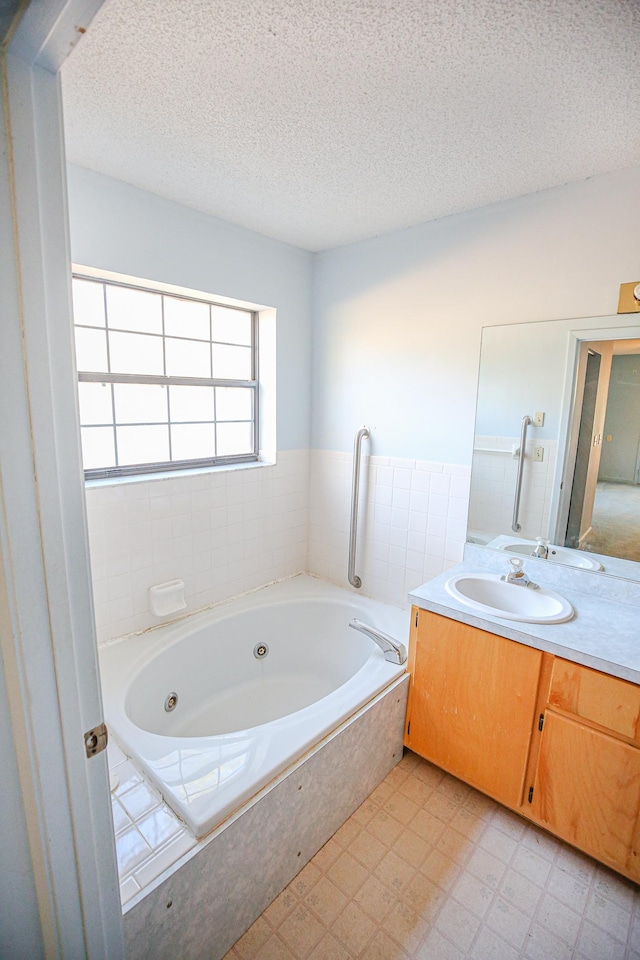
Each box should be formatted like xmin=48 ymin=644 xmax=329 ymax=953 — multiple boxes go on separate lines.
xmin=118 ymin=675 xmax=408 ymax=960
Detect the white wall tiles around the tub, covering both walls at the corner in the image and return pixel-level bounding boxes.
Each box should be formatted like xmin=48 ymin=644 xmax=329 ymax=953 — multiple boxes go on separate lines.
xmin=87 ymin=450 xmax=470 ymax=641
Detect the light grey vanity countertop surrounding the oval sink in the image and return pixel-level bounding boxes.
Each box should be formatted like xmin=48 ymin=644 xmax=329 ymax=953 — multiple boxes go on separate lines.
xmin=409 ymin=551 xmax=640 ymax=685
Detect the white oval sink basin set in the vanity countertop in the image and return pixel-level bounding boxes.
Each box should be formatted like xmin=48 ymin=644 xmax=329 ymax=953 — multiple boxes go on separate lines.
xmin=445 ymin=573 xmax=574 ymax=623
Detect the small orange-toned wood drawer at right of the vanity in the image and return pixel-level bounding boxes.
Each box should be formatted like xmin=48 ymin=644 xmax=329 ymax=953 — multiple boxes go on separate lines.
xmin=549 ymin=657 xmax=640 ymax=741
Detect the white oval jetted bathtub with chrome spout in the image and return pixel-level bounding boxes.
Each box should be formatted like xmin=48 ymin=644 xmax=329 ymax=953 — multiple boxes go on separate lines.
xmin=100 ymin=576 xmax=409 ymax=837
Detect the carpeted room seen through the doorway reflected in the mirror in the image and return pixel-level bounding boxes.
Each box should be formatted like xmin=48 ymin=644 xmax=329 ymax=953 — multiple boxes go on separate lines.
xmin=567 ymin=340 xmax=640 ymax=561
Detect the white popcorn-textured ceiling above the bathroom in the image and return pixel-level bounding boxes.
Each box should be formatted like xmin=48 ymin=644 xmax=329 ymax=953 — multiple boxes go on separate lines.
xmin=63 ymin=0 xmax=640 ymax=250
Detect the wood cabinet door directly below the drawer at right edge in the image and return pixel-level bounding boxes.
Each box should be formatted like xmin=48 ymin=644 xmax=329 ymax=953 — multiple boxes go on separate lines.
xmin=531 ymin=711 xmax=640 ymax=880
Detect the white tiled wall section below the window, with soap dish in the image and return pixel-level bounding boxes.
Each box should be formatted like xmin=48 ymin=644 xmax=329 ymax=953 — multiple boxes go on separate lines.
xmin=86 ymin=450 xmax=309 ymax=640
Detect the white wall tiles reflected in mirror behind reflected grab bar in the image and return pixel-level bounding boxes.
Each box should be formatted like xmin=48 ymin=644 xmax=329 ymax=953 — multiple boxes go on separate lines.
xmin=469 ymin=431 xmax=558 ymax=539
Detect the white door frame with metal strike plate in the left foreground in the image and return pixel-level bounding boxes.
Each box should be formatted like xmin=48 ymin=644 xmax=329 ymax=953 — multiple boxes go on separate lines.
xmin=0 ymin=0 xmax=124 ymax=960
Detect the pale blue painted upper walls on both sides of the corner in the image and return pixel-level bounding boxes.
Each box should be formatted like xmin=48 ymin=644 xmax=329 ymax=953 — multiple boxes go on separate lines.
xmin=69 ymin=167 xmax=640 ymax=464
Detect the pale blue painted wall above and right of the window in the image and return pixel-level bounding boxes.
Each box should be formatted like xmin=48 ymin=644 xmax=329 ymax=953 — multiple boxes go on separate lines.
xmin=68 ymin=166 xmax=313 ymax=450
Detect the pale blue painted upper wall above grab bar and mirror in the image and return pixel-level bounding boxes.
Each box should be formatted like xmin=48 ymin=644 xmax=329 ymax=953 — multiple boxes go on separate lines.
xmin=312 ymin=168 xmax=640 ymax=464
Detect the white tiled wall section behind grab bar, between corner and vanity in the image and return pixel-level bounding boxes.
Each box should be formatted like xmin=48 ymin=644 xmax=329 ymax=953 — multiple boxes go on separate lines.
xmin=309 ymin=450 xmax=471 ymax=605
